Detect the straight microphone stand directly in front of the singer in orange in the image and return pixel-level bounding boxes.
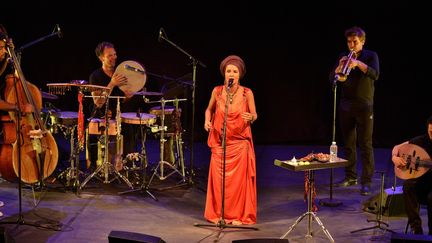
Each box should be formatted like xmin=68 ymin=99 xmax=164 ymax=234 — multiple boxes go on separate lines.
xmin=194 ymin=85 xmax=258 ymax=242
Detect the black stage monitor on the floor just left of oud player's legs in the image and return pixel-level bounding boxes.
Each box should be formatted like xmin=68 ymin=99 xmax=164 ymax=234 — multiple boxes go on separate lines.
xmin=363 ymin=186 xmax=407 ymax=217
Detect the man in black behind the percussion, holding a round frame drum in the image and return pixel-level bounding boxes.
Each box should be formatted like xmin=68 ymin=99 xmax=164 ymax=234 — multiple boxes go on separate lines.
xmin=89 ymin=42 xmax=140 ymax=170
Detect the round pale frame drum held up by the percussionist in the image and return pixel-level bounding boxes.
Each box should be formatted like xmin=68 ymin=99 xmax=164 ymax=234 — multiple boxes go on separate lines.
xmin=115 ymin=61 xmax=147 ymax=93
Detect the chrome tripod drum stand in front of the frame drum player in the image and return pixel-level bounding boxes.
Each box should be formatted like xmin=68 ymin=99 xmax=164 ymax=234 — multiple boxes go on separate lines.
xmin=80 ymin=97 xmax=133 ymax=190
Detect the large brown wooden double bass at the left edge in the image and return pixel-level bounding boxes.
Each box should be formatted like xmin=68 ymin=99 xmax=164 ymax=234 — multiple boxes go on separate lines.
xmin=0 ymin=37 xmax=58 ymax=184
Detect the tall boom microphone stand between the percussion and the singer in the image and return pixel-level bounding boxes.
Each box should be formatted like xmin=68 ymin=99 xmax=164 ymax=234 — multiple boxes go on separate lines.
xmin=159 ymin=28 xmax=207 ymax=185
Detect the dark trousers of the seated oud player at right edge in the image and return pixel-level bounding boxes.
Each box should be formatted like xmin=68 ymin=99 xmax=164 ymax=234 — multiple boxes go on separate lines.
xmin=403 ymin=170 xmax=432 ymax=234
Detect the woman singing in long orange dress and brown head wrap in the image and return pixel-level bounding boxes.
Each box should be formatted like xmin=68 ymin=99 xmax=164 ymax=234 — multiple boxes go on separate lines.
xmin=204 ymin=55 xmax=258 ymax=225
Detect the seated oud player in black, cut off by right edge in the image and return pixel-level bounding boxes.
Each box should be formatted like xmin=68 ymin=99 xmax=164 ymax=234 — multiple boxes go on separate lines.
xmin=392 ymin=116 xmax=432 ymax=235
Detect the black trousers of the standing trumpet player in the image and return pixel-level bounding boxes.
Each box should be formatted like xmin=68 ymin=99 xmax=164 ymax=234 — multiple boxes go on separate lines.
xmin=339 ymin=104 xmax=375 ymax=185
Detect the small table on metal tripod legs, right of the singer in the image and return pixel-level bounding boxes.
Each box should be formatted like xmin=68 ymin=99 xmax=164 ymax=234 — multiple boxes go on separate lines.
xmin=274 ymin=158 xmax=348 ymax=242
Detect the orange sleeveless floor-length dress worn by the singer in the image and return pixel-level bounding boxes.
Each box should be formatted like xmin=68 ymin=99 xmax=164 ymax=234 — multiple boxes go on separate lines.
xmin=204 ymin=86 xmax=257 ymax=224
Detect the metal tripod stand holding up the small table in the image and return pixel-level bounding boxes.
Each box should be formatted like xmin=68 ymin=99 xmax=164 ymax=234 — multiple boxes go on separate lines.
xmin=280 ymin=170 xmax=334 ymax=242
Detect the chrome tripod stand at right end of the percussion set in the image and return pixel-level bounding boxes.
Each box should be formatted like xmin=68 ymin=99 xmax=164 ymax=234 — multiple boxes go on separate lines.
xmin=148 ymin=98 xmax=186 ymax=189
